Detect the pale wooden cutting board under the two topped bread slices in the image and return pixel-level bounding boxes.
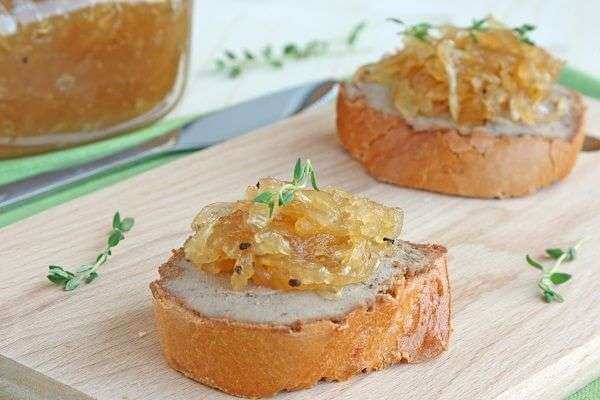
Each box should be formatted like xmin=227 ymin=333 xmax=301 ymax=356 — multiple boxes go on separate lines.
xmin=0 ymin=100 xmax=600 ymax=400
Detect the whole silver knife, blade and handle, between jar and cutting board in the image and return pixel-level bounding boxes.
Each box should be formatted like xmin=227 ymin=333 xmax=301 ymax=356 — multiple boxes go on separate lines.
xmin=0 ymin=80 xmax=338 ymax=210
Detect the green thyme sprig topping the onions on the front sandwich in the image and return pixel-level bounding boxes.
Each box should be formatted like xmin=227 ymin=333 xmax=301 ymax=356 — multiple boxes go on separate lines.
xmin=254 ymin=158 xmax=319 ymax=218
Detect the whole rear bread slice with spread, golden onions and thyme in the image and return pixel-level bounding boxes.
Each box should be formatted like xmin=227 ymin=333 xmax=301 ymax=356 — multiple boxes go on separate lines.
xmin=337 ymin=18 xmax=585 ymax=198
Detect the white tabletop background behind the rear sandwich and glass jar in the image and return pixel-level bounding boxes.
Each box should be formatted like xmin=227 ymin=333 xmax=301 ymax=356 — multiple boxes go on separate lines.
xmin=171 ymin=0 xmax=600 ymax=116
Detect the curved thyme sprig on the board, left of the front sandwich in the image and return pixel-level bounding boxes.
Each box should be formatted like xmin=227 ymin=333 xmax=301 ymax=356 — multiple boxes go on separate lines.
xmin=47 ymin=211 xmax=134 ymax=290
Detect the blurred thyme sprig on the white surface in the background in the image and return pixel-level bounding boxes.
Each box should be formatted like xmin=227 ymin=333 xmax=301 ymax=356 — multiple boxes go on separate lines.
xmin=215 ymin=21 xmax=367 ymax=78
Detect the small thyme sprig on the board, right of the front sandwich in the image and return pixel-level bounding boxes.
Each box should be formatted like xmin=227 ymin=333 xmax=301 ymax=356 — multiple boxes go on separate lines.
xmin=525 ymin=239 xmax=587 ymax=303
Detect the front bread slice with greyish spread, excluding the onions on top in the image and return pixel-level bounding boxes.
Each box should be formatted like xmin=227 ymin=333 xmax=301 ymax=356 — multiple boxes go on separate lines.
xmin=150 ymin=240 xmax=451 ymax=397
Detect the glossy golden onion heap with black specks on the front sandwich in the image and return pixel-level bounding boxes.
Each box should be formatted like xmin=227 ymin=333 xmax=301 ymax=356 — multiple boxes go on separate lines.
xmin=185 ymin=179 xmax=403 ymax=295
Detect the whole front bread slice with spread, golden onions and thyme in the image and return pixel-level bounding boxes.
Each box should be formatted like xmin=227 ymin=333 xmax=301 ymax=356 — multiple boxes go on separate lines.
xmin=150 ymin=160 xmax=450 ymax=397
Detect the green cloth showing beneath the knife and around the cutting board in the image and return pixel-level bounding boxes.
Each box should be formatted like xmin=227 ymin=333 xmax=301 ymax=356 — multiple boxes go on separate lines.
xmin=0 ymin=67 xmax=600 ymax=400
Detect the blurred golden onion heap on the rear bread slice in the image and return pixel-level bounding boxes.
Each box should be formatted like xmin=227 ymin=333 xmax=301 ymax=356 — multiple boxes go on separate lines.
xmin=355 ymin=20 xmax=564 ymax=126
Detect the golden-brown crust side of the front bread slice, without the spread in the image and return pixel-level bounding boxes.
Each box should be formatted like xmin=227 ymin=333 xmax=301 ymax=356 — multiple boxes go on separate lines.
xmin=150 ymin=245 xmax=451 ymax=397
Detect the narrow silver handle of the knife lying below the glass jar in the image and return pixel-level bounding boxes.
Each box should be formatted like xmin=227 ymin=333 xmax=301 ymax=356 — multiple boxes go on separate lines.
xmin=0 ymin=133 xmax=176 ymax=209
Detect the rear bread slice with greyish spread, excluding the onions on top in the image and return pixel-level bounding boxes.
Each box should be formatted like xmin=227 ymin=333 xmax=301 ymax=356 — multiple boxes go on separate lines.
xmin=337 ymin=83 xmax=585 ymax=198
